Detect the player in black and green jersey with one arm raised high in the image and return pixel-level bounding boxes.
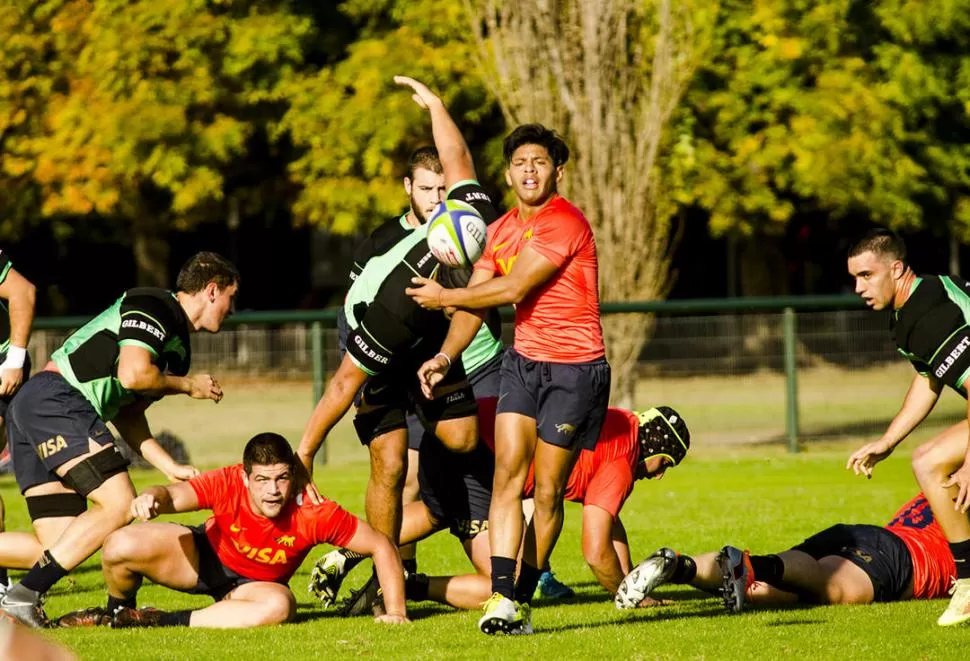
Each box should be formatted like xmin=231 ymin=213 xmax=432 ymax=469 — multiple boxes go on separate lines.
xmin=297 ymin=76 xmax=498 ymax=604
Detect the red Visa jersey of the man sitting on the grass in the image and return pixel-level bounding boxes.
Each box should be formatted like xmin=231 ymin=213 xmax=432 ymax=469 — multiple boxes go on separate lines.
xmin=189 ymin=464 xmax=358 ymax=583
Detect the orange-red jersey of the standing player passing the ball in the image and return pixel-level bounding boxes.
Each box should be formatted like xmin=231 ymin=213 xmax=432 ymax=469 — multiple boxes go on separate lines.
xmin=475 ymin=195 xmax=606 ymax=363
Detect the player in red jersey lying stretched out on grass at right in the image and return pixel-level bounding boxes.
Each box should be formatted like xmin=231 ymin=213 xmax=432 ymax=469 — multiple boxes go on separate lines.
xmin=616 ymin=494 xmax=956 ymax=612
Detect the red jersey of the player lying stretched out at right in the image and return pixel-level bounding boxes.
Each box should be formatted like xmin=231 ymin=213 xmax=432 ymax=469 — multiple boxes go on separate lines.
xmin=886 ymin=494 xmax=957 ymax=599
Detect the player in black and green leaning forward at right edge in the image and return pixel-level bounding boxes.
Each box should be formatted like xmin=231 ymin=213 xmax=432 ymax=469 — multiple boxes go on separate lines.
xmin=846 ymin=229 xmax=970 ymax=626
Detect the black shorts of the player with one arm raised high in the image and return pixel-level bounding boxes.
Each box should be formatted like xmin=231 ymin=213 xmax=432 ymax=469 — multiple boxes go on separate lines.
xmin=354 ymin=349 xmax=478 ymax=445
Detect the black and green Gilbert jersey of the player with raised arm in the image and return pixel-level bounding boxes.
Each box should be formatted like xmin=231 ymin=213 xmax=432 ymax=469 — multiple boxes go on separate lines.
xmin=344 ymin=181 xmax=498 ymax=374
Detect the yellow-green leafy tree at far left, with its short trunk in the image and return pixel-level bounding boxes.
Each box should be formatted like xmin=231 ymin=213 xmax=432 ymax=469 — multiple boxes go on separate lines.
xmin=0 ymin=0 xmax=313 ymax=286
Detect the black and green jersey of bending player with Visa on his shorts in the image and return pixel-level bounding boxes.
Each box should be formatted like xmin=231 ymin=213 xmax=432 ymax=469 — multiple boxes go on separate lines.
xmin=51 ymin=287 xmax=192 ymax=422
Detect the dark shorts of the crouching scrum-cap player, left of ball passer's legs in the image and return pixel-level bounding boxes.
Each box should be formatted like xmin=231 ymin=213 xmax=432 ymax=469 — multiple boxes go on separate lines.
xmin=418 ymin=435 xmax=495 ymax=541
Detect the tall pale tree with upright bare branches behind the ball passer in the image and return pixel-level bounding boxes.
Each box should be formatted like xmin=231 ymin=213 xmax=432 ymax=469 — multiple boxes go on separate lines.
xmin=465 ymin=0 xmax=716 ymax=406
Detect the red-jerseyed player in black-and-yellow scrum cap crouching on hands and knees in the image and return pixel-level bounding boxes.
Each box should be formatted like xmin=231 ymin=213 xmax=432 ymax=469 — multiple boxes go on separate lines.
xmin=316 ymin=398 xmax=690 ymax=612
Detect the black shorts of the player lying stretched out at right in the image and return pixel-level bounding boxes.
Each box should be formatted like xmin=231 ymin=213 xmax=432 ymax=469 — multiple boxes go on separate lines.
xmin=792 ymin=523 xmax=913 ymax=601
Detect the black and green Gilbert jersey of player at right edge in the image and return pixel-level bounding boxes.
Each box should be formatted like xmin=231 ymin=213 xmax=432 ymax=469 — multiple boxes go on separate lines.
xmin=891 ymin=275 xmax=970 ymax=397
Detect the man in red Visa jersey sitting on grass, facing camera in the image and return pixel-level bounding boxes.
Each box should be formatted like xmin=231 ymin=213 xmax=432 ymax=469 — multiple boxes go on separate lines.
xmin=59 ymin=433 xmax=408 ymax=628
